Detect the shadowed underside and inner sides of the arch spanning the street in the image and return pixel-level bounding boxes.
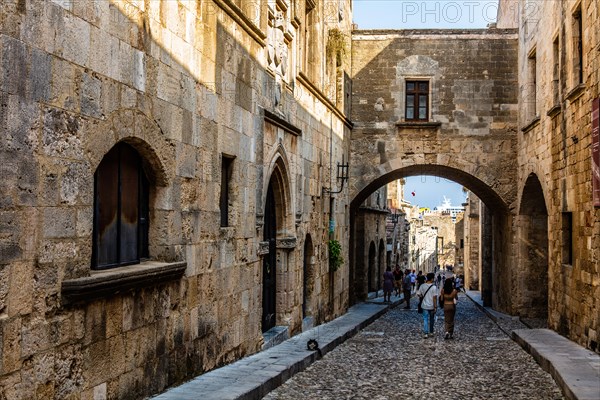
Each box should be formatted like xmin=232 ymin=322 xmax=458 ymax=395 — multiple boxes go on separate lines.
xmin=349 ymin=165 xmax=513 ymax=311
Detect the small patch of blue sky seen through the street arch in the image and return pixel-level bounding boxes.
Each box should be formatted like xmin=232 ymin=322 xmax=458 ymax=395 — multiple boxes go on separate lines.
xmin=404 ymin=175 xmax=466 ymax=209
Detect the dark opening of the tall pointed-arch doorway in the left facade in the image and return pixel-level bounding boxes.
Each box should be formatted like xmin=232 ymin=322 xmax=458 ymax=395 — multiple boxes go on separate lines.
xmin=262 ymin=184 xmax=277 ymax=332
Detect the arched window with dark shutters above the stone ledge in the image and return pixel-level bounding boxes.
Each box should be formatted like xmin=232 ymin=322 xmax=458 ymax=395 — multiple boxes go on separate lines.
xmin=92 ymin=142 xmax=149 ymax=269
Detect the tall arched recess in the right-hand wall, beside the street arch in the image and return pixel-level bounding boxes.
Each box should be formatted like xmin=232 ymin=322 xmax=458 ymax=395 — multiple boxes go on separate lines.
xmin=517 ymin=174 xmax=548 ymax=319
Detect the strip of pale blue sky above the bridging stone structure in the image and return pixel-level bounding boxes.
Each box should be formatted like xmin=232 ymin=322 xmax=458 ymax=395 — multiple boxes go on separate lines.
xmin=352 ymin=0 xmax=498 ymax=29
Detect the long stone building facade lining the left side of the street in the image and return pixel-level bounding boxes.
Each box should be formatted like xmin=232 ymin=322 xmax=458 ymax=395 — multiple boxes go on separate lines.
xmin=0 ymin=0 xmax=352 ymax=399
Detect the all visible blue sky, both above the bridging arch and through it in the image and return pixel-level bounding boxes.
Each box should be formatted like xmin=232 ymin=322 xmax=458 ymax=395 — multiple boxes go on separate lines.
xmin=352 ymin=0 xmax=498 ymax=208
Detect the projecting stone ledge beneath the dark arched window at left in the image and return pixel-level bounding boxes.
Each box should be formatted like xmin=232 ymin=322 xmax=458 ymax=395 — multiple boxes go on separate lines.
xmin=61 ymin=261 xmax=187 ymax=303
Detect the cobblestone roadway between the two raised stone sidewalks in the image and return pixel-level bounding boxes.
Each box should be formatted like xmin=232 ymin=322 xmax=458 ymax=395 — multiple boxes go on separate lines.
xmin=265 ymin=295 xmax=563 ymax=400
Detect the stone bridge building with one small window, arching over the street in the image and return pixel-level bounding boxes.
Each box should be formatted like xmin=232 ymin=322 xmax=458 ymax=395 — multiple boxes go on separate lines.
xmin=349 ymin=29 xmax=519 ymax=313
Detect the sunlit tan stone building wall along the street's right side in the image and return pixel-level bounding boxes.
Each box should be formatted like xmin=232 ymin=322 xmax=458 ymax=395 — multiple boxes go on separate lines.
xmin=518 ymin=0 xmax=600 ymax=352
